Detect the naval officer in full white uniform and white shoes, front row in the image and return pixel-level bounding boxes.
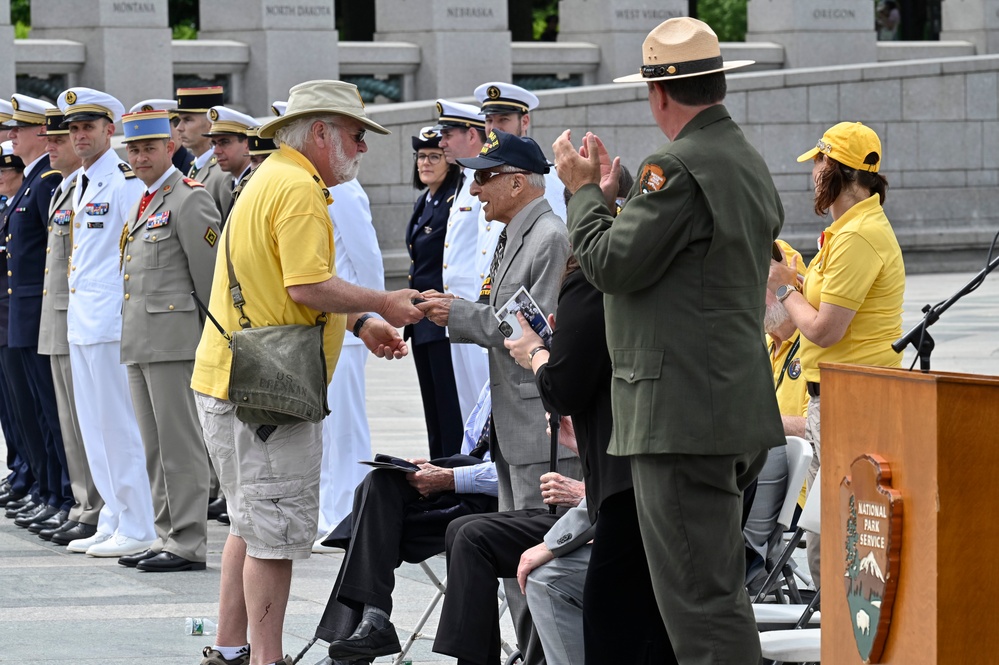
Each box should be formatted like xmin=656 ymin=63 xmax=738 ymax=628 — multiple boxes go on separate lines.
xmin=58 ymin=88 xmax=156 ymax=557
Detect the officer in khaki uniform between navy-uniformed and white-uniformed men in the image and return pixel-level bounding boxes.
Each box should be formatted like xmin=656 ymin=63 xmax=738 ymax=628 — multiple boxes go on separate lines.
xmin=38 ymin=108 xmax=104 ymax=545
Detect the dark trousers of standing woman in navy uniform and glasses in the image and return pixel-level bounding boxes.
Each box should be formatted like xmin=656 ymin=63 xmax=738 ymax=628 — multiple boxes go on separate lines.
xmin=413 ymin=339 xmax=464 ymax=459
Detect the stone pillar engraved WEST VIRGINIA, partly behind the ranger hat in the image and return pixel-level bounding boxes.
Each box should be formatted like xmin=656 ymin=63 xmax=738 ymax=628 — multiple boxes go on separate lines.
xmin=558 ymin=0 xmax=688 ymax=84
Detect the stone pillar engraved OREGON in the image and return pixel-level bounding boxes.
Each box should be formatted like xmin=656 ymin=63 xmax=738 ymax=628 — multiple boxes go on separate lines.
xmin=746 ymin=0 xmax=880 ymax=68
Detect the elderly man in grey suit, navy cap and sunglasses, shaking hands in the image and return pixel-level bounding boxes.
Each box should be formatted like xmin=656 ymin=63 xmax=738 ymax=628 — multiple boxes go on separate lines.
xmin=419 ymin=130 xmax=581 ymax=511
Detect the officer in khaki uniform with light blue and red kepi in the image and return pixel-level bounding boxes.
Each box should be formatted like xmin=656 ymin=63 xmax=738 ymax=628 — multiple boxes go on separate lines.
xmin=118 ymin=111 xmax=219 ymax=572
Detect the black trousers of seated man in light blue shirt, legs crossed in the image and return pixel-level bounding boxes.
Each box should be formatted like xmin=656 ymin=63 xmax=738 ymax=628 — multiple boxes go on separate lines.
xmin=316 ymin=455 xmax=496 ymax=642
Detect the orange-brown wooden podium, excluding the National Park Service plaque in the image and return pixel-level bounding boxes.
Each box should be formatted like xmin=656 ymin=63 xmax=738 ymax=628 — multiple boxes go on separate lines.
xmin=821 ymin=364 xmax=999 ymax=665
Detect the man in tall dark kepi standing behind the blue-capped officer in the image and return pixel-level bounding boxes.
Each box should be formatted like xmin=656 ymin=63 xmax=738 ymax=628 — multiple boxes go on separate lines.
xmin=177 ymin=85 xmax=232 ymax=218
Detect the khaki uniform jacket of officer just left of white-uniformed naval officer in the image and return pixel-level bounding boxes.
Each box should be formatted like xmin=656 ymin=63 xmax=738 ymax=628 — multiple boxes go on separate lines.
xmin=38 ymin=182 xmax=76 ymax=356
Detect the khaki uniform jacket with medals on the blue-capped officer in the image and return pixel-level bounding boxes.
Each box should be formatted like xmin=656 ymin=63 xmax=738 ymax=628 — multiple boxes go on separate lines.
xmin=121 ymin=166 xmax=219 ymax=364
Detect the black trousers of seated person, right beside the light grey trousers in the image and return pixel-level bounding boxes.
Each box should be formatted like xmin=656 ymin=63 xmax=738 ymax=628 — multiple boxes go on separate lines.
xmin=434 ymin=508 xmax=559 ymax=665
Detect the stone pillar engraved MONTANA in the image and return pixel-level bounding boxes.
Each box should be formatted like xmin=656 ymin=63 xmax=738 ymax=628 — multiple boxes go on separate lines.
xmin=30 ymin=0 xmax=173 ymax=109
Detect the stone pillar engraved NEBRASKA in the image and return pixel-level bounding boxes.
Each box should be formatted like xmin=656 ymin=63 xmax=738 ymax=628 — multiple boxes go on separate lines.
xmin=375 ymin=0 xmax=513 ymax=99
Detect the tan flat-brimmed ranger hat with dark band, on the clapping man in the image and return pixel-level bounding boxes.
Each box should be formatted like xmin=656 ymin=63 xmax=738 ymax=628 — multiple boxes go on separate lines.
xmin=614 ymin=16 xmax=756 ymax=83
